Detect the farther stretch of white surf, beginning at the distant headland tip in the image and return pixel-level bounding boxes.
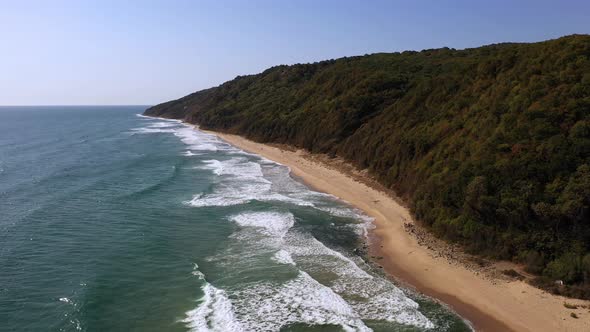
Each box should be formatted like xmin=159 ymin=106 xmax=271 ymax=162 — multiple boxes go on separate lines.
xmin=135 ymin=117 xmax=380 ymax=228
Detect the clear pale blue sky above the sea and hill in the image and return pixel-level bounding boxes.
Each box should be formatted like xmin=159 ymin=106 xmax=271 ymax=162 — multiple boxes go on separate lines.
xmin=0 ymin=0 xmax=590 ymax=105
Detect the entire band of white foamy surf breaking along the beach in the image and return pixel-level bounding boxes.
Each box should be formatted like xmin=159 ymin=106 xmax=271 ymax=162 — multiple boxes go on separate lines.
xmin=139 ymin=117 xmax=434 ymax=331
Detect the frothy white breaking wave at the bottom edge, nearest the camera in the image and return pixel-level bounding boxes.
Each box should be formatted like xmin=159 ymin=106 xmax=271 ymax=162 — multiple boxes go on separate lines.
xmin=182 ymin=264 xmax=371 ymax=332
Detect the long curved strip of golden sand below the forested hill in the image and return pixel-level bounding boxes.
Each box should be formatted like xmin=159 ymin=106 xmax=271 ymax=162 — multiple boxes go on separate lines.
xmin=204 ymin=132 xmax=590 ymax=332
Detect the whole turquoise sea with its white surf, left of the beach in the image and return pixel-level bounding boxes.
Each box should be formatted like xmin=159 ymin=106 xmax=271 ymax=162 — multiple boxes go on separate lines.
xmin=0 ymin=106 xmax=469 ymax=331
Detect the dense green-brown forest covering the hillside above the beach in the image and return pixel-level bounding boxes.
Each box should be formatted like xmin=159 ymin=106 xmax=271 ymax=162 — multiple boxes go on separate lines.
xmin=145 ymin=35 xmax=590 ymax=298
